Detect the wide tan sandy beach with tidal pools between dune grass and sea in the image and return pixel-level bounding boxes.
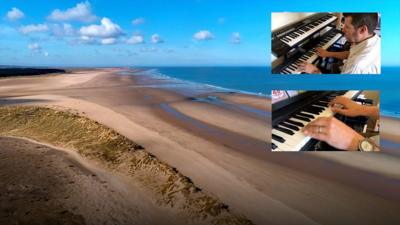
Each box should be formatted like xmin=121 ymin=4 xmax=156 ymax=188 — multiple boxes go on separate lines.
xmin=0 ymin=68 xmax=400 ymax=225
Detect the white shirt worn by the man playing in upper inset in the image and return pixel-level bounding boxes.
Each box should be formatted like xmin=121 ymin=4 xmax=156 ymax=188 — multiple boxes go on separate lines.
xmin=342 ymin=34 xmax=381 ymax=74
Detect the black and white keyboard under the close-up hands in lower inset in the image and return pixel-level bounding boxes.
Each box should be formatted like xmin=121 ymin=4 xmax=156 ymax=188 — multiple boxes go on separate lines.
xmin=271 ymin=90 xmax=361 ymax=151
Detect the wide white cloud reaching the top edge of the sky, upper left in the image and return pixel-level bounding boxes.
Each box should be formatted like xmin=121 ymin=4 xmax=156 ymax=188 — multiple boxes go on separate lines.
xmin=47 ymin=1 xmax=96 ymax=22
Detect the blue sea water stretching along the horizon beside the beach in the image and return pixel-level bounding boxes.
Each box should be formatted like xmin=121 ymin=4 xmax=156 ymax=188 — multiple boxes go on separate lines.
xmin=134 ymin=67 xmax=400 ymax=118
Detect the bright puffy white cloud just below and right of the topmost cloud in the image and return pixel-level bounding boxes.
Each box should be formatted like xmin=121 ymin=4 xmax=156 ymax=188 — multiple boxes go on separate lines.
xmin=80 ymin=17 xmax=123 ymax=38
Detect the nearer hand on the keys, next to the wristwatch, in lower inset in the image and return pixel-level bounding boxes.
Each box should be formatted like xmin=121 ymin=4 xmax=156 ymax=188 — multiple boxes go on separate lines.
xmin=303 ymin=117 xmax=364 ymax=151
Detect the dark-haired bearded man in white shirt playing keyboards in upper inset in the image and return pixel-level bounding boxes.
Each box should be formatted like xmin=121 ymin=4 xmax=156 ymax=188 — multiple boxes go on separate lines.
xmin=300 ymin=13 xmax=381 ymax=74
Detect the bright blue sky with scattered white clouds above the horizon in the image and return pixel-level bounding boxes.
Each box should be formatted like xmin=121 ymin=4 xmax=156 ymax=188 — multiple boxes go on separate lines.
xmin=0 ymin=0 xmax=400 ymax=66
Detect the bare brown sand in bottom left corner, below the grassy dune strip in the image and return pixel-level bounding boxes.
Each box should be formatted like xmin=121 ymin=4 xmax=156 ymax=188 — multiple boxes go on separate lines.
xmin=0 ymin=137 xmax=179 ymax=224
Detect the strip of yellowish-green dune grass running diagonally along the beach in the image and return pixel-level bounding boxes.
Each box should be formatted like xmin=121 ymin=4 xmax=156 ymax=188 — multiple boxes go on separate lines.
xmin=0 ymin=106 xmax=253 ymax=225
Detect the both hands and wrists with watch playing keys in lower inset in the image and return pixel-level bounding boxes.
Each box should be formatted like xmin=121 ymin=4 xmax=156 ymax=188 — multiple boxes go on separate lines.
xmin=303 ymin=96 xmax=379 ymax=151
